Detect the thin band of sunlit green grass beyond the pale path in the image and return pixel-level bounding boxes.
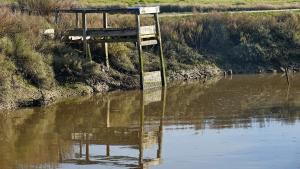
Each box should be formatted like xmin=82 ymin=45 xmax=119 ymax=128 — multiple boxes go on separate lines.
xmin=2 ymin=0 xmax=300 ymax=8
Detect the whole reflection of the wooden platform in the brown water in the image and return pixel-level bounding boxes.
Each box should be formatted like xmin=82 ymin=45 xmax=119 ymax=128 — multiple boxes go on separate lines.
xmin=62 ymin=90 xmax=166 ymax=168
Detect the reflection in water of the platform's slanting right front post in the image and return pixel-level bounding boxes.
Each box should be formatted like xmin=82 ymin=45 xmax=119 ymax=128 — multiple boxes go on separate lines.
xmin=157 ymin=87 xmax=167 ymax=158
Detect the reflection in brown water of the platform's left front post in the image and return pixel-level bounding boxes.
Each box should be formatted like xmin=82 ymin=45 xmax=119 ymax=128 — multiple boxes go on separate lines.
xmin=139 ymin=92 xmax=145 ymax=165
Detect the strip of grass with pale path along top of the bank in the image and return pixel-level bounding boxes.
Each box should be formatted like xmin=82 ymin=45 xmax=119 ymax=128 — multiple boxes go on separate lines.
xmin=4 ymin=0 xmax=300 ymax=12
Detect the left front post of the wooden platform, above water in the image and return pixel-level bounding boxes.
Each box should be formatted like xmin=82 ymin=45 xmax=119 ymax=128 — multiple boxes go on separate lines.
xmin=136 ymin=14 xmax=144 ymax=90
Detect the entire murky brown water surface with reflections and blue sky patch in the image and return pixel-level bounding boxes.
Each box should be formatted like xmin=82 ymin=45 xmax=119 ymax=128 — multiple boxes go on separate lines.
xmin=0 ymin=75 xmax=300 ymax=169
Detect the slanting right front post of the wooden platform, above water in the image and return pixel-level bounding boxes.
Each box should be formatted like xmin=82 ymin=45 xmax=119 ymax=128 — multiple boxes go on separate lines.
xmin=154 ymin=13 xmax=167 ymax=87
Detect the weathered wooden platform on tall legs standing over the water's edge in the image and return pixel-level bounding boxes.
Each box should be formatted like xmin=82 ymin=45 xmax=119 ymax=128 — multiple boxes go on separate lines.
xmin=53 ymin=6 xmax=166 ymax=89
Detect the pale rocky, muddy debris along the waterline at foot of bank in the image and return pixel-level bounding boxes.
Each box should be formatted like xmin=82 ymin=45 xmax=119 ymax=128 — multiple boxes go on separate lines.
xmin=0 ymin=65 xmax=222 ymax=110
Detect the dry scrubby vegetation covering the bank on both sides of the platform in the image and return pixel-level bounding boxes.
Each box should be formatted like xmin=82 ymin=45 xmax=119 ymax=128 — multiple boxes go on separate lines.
xmin=0 ymin=0 xmax=300 ymax=108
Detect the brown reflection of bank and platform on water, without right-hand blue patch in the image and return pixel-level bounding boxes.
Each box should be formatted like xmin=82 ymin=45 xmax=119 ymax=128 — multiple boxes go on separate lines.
xmin=0 ymin=75 xmax=300 ymax=169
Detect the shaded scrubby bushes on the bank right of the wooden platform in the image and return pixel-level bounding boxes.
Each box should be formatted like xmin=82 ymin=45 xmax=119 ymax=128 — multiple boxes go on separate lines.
xmin=162 ymin=13 xmax=300 ymax=73
